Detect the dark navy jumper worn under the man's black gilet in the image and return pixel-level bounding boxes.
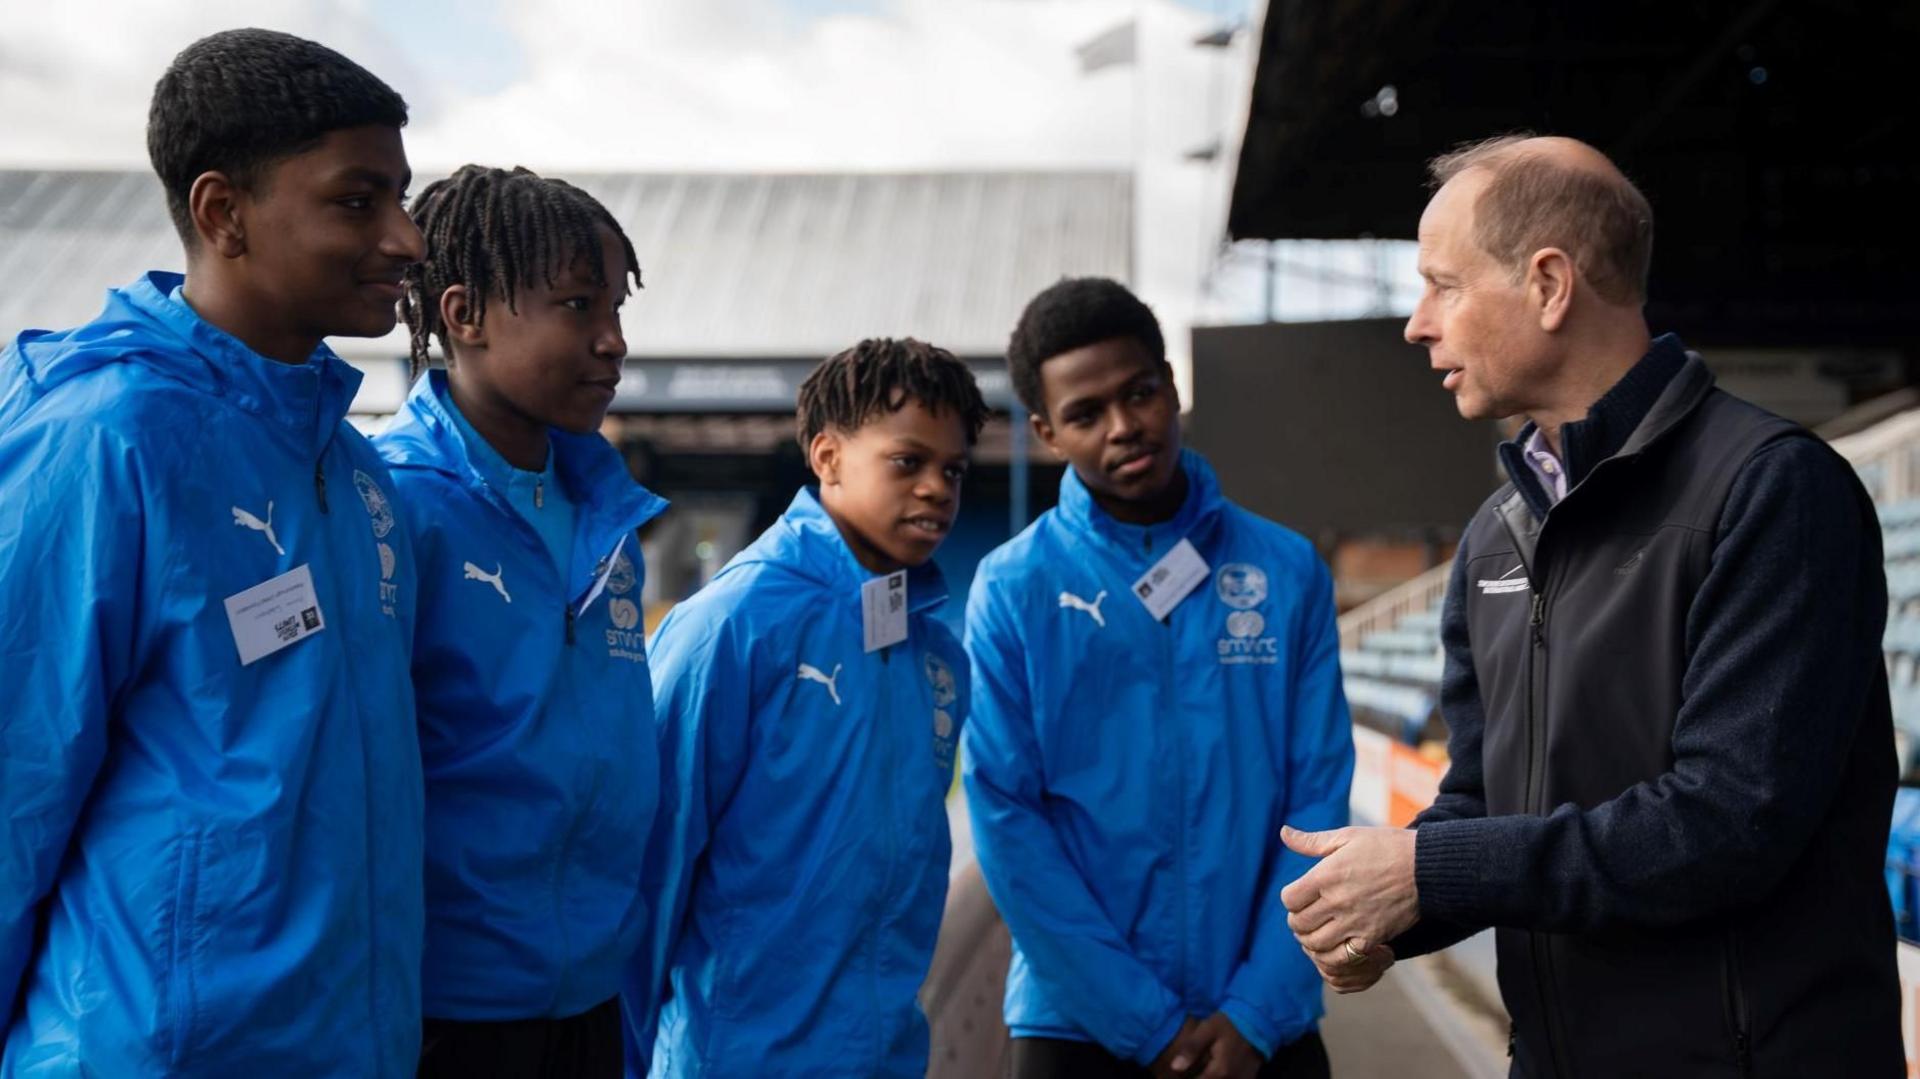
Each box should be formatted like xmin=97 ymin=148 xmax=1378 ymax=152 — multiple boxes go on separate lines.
xmin=1394 ymin=336 xmax=1891 ymax=956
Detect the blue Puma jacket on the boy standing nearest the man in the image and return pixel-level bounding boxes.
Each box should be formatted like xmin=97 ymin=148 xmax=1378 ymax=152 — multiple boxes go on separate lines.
xmin=964 ymin=451 xmax=1354 ymax=1064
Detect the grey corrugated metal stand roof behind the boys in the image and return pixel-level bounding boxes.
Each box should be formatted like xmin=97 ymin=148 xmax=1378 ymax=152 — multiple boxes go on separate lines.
xmin=0 ymin=171 xmax=1133 ymax=359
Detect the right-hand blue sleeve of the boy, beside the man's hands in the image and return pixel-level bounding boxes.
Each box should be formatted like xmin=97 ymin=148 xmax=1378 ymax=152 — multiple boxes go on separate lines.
xmin=1221 ymin=559 xmax=1354 ymax=1056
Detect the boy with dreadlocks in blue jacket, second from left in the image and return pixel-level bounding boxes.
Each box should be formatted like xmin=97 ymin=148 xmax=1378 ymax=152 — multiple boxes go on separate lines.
xmin=376 ymin=165 xmax=666 ymax=1079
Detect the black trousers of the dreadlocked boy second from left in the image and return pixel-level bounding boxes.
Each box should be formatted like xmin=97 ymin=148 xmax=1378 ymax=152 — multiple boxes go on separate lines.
xmin=419 ymin=998 xmax=624 ymax=1079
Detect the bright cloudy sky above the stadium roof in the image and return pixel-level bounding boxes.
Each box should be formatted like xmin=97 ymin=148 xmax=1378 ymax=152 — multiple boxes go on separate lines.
xmin=0 ymin=0 xmax=1413 ymax=389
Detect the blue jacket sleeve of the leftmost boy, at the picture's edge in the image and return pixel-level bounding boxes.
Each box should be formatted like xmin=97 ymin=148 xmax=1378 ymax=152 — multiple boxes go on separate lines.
xmin=0 ymin=422 xmax=144 ymax=1019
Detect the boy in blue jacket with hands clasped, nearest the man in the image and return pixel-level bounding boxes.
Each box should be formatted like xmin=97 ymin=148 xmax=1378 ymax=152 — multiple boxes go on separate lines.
xmin=964 ymin=278 xmax=1354 ymax=1079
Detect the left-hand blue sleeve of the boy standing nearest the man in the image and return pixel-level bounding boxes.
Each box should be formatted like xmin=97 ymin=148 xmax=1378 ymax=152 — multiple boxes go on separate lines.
xmin=964 ymin=576 xmax=1185 ymax=1064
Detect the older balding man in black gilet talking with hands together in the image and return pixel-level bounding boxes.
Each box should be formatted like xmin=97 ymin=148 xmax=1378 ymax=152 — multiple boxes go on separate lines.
xmin=1283 ymin=136 xmax=1905 ymax=1079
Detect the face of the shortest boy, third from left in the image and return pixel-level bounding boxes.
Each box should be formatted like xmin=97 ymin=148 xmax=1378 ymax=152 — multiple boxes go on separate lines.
xmin=806 ymin=399 xmax=972 ymax=572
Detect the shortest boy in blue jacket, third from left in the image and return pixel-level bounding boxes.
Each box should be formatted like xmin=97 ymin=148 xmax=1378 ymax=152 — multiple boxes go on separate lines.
xmin=624 ymin=340 xmax=987 ymax=1079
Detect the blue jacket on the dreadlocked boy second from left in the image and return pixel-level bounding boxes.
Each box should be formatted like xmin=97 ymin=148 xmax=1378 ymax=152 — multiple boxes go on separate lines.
xmin=374 ymin=371 xmax=666 ymax=1021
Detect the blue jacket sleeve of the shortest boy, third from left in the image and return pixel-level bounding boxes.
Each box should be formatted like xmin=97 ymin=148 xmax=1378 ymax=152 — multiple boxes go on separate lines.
xmin=620 ymin=603 xmax=753 ymax=1079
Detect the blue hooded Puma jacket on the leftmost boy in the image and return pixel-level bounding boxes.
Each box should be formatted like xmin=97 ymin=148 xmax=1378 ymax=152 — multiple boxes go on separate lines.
xmin=0 ymin=273 xmax=422 ymax=1077
